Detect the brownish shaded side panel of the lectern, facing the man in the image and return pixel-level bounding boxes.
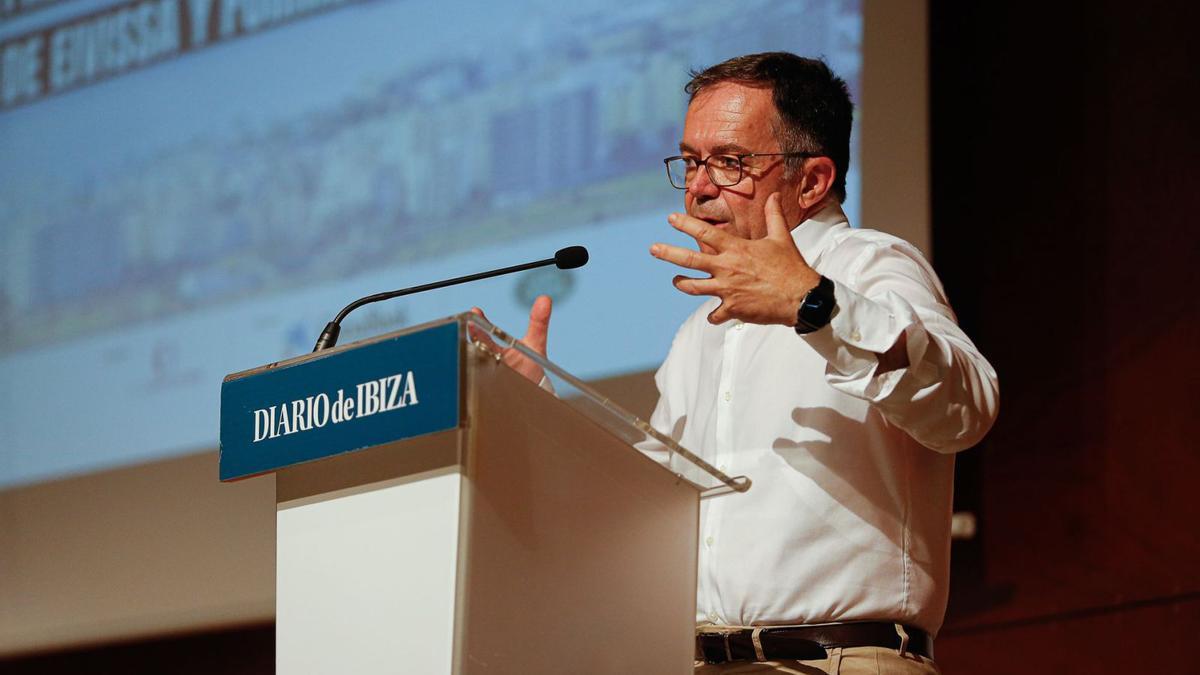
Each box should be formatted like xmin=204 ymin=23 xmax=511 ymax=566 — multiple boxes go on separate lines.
xmin=460 ymin=362 xmax=700 ymax=674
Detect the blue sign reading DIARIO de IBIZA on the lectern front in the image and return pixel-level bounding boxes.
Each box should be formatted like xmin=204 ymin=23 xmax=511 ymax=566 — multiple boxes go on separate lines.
xmin=221 ymin=322 xmax=460 ymax=480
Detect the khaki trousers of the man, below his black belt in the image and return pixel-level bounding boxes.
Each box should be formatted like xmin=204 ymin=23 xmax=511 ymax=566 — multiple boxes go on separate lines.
xmin=695 ymin=647 xmax=941 ymax=675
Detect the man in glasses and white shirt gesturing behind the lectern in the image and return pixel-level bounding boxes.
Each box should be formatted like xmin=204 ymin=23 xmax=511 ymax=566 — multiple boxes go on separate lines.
xmin=492 ymin=53 xmax=998 ymax=674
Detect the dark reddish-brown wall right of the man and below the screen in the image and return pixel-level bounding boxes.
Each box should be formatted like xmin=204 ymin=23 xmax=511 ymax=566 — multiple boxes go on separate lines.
xmin=0 ymin=0 xmax=1200 ymax=674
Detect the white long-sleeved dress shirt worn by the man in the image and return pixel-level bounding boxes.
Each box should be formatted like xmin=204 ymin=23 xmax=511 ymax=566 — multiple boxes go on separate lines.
xmin=650 ymin=198 xmax=998 ymax=634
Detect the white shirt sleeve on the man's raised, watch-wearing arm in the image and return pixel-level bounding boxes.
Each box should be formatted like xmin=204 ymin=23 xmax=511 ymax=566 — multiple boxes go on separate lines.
xmin=802 ymin=239 xmax=1000 ymax=453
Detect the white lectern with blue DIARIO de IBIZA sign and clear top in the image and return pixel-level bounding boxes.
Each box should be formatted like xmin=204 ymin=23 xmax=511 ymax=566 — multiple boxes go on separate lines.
xmin=221 ymin=313 xmax=749 ymax=675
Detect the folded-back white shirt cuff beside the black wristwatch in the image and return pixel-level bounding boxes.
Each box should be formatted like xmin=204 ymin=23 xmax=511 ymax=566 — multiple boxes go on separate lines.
xmin=800 ymin=281 xmax=929 ymax=401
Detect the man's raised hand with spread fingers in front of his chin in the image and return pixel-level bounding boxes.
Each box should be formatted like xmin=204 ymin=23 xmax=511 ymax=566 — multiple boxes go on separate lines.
xmin=650 ymin=192 xmax=821 ymax=325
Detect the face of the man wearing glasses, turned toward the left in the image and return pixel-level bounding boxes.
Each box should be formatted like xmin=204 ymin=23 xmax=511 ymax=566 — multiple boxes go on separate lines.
xmin=679 ymin=82 xmax=799 ymax=239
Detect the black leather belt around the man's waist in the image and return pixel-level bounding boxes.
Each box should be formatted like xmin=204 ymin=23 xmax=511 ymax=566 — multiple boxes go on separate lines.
xmin=696 ymin=622 xmax=934 ymax=663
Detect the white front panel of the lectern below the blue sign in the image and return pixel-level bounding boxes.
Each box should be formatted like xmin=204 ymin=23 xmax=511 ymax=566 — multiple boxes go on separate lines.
xmin=275 ymin=470 xmax=462 ymax=675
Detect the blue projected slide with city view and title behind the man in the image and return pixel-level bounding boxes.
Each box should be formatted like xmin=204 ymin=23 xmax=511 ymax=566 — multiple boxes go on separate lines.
xmin=0 ymin=0 xmax=862 ymax=485
